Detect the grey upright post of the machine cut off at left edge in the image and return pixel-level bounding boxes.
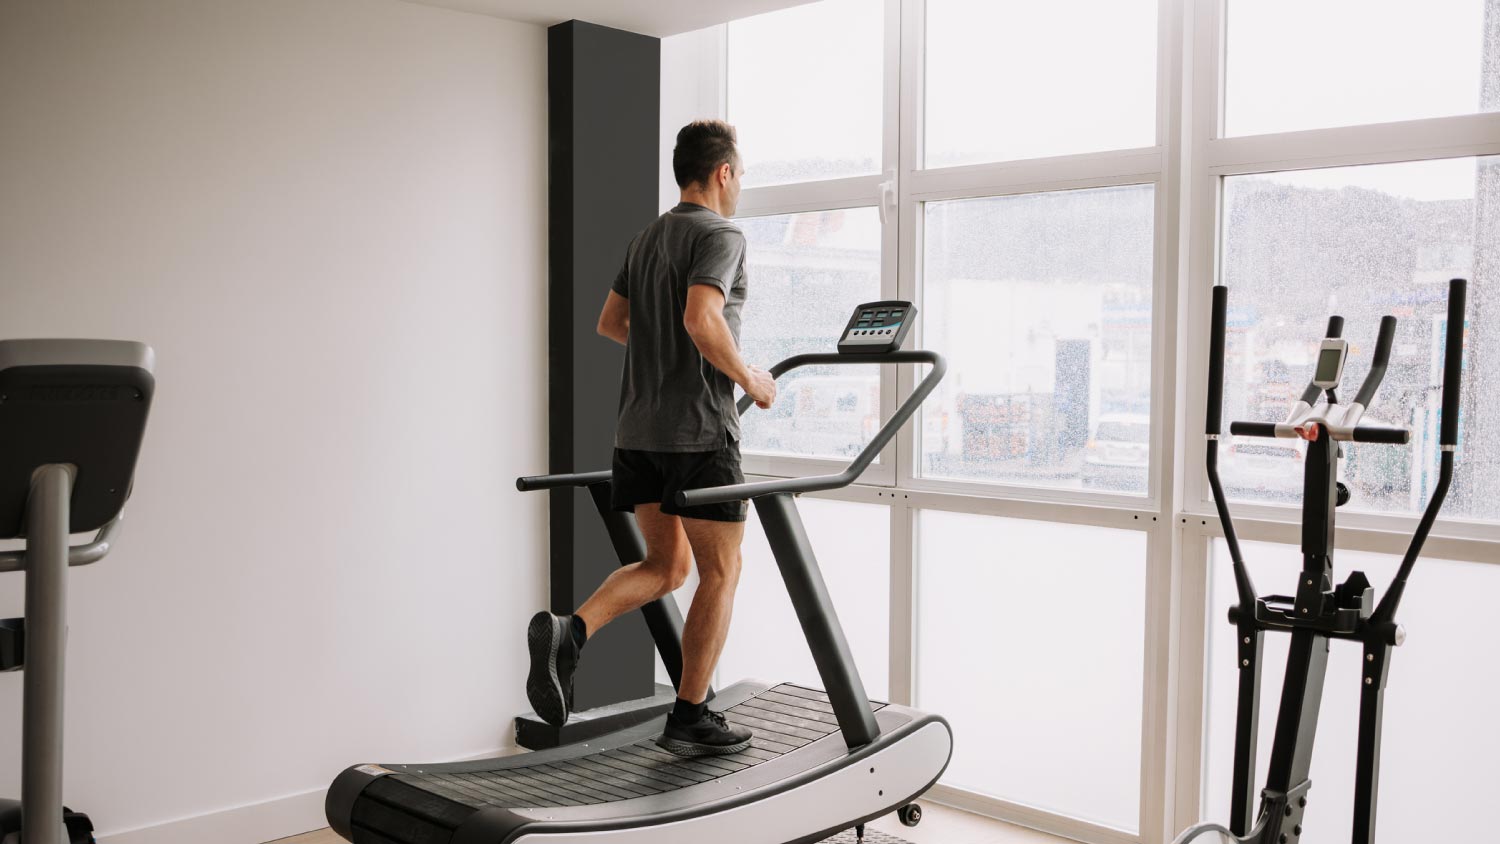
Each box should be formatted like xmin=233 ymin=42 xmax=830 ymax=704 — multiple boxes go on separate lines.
xmin=21 ymin=465 xmax=74 ymax=844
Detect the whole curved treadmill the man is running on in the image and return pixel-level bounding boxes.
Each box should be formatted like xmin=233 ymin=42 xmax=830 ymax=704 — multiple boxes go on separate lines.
xmin=326 ymin=301 xmax=953 ymax=844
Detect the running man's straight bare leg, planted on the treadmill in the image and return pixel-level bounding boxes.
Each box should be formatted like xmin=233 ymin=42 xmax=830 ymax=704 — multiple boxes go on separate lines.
xmin=677 ymin=519 xmax=746 ymax=703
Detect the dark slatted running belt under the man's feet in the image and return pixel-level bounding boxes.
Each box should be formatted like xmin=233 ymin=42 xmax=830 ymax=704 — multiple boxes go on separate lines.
xmin=396 ymin=684 xmax=879 ymax=809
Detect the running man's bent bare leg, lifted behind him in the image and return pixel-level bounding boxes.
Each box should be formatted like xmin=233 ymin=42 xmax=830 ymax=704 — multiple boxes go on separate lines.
xmin=573 ymin=504 xmax=693 ymax=637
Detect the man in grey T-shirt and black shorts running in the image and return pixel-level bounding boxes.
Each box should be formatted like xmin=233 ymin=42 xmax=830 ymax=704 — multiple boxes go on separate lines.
xmin=527 ymin=120 xmax=776 ymax=756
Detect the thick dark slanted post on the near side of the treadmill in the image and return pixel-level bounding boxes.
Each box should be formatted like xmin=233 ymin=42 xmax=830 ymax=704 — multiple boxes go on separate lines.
xmin=753 ymin=492 xmax=881 ymax=750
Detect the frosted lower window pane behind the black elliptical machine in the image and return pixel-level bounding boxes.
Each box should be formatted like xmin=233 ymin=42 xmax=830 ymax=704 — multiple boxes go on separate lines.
xmin=1203 ymin=540 xmax=1500 ymax=841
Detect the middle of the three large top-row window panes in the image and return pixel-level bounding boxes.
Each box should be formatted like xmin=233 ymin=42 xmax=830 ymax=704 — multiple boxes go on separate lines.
xmin=924 ymin=0 xmax=1157 ymax=168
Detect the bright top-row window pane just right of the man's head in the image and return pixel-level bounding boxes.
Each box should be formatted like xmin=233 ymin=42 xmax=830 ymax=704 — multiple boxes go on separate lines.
xmin=728 ymin=0 xmax=885 ymax=187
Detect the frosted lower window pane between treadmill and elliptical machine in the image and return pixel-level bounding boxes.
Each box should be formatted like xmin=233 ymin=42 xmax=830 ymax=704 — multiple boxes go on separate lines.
xmin=917 ymin=510 xmax=1146 ymax=831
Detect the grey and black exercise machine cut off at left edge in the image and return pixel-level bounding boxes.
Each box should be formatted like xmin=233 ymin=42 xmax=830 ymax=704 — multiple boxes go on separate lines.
xmin=0 ymin=340 xmax=156 ymax=844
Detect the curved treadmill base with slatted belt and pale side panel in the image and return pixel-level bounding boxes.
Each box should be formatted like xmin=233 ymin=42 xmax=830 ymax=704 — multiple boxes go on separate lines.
xmin=327 ymin=682 xmax=953 ymax=844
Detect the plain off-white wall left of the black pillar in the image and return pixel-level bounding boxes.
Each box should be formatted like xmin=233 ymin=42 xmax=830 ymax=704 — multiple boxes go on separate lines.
xmin=0 ymin=0 xmax=546 ymax=844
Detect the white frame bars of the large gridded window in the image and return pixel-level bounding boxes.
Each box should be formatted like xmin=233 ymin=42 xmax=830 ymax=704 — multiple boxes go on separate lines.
xmin=672 ymin=0 xmax=1500 ymax=844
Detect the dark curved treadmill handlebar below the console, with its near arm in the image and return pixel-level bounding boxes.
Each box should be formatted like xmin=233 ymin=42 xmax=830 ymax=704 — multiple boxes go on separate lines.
xmin=677 ymin=349 xmax=948 ymax=507
